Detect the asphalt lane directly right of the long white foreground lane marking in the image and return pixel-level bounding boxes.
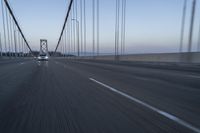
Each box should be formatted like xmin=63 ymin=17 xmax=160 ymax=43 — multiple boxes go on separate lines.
xmin=55 ymin=58 xmax=200 ymax=127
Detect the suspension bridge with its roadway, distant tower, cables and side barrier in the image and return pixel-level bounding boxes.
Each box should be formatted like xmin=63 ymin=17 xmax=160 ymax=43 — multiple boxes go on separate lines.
xmin=0 ymin=0 xmax=200 ymax=133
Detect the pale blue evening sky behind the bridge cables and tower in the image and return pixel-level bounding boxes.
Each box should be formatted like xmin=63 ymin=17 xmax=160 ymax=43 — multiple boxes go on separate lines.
xmin=0 ymin=0 xmax=200 ymax=53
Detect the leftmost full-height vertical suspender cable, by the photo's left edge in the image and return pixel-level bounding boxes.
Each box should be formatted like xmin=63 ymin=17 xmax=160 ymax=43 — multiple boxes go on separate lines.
xmin=1 ymin=0 xmax=7 ymax=53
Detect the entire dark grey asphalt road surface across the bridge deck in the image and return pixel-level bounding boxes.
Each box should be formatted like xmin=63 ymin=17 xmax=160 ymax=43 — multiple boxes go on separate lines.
xmin=0 ymin=59 xmax=200 ymax=133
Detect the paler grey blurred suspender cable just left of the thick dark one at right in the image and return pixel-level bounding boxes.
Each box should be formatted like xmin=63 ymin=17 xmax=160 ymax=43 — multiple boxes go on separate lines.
xmin=179 ymin=0 xmax=187 ymax=52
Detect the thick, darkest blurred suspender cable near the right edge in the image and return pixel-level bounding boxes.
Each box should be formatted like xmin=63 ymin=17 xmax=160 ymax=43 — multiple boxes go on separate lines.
xmin=188 ymin=0 xmax=196 ymax=52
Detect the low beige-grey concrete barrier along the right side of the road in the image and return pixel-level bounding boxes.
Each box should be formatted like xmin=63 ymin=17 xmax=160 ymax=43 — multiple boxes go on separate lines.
xmin=81 ymin=52 xmax=200 ymax=63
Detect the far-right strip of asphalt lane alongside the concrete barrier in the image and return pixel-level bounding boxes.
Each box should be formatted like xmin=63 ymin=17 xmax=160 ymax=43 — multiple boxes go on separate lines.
xmin=63 ymin=60 xmax=200 ymax=88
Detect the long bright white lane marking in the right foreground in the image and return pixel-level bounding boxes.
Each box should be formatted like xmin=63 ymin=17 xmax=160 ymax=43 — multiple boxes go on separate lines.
xmin=89 ymin=78 xmax=200 ymax=133
